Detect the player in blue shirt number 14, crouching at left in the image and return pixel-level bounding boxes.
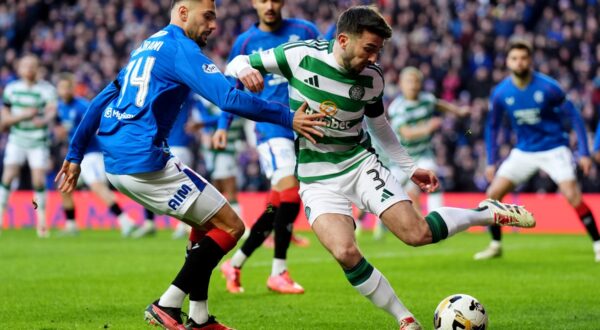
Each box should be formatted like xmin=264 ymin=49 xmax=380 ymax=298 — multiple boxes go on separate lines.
xmin=56 ymin=0 xmax=323 ymax=329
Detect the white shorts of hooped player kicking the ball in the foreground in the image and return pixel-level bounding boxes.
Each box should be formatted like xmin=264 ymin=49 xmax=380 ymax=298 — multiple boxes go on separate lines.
xmin=300 ymin=155 xmax=410 ymax=226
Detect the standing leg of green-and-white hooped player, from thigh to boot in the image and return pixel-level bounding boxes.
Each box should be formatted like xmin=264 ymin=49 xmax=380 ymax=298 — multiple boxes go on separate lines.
xmin=312 ymin=213 xmax=422 ymax=330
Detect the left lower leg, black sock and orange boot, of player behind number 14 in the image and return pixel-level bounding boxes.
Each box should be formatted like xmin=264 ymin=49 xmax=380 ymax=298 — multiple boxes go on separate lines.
xmin=221 ymin=190 xmax=280 ymax=293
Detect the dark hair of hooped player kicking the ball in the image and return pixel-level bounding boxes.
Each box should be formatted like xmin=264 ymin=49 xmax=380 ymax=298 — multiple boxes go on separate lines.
xmin=336 ymin=6 xmax=392 ymax=39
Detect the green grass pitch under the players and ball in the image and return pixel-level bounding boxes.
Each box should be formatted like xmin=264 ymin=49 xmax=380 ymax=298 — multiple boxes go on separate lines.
xmin=0 ymin=230 xmax=600 ymax=329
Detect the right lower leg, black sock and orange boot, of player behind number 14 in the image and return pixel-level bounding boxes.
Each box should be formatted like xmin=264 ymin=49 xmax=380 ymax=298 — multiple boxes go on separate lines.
xmin=267 ymin=187 xmax=304 ymax=294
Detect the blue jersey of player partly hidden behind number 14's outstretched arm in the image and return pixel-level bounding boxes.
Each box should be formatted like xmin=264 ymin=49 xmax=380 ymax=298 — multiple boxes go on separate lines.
xmin=219 ymin=19 xmax=319 ymax=143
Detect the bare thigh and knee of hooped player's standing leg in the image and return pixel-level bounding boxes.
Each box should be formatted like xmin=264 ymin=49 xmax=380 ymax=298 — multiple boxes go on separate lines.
xmin=312 ymin=213 xmax=362 ymax=269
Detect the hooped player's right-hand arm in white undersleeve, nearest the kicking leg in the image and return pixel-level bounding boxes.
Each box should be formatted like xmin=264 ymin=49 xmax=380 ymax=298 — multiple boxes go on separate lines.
xmin=365 ymin=99 xmax=439 ymax=192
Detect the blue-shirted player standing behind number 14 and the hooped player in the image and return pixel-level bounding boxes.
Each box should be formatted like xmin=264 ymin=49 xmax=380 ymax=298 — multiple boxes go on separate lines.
xmin=213 ymin=0 xmax=319 ymax=294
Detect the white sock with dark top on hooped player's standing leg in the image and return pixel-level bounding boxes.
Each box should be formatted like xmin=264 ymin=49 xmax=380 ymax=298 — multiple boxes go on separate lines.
xmin=344 ymin=258 xmax=412 ymax=321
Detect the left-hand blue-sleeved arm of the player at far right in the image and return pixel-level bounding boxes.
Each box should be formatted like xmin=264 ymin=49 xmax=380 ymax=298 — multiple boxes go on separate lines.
xmin=484 ymin=93 xmax=504 ymax=182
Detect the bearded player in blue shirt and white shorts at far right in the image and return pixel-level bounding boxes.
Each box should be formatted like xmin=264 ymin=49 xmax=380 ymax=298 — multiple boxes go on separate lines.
xmin=475 ymin=39 xmax=600 ymax=262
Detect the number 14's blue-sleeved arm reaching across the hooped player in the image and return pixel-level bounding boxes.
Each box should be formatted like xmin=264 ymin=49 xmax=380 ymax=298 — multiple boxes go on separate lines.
xmin=174 ymin=47 xmax=325 ymax=142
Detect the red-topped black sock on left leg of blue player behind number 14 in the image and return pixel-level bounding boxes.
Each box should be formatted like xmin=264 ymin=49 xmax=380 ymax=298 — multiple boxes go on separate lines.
xmin=240 ymin=190 xmax=280 ymax=260
